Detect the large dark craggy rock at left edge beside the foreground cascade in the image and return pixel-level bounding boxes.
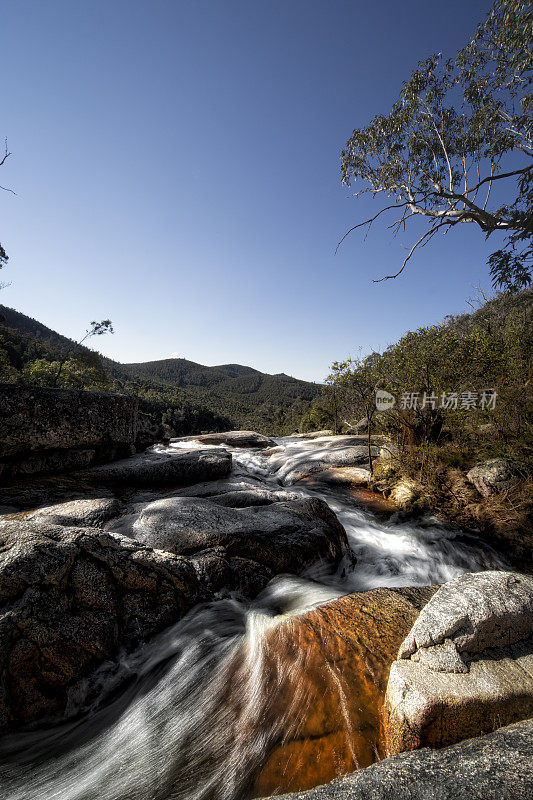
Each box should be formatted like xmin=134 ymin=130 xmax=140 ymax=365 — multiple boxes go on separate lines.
xmin=0 ymin=520 xmax=200 ymax=730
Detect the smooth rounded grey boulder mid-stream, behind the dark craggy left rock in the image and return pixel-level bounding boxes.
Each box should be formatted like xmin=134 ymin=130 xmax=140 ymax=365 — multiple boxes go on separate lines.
xmin=127 ymin=496 xmax=349 ymax=574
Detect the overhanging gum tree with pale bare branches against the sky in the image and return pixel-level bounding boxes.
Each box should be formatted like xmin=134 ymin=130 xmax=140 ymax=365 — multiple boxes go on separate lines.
xmin=339 ymin=0 xmax=533 ymax=292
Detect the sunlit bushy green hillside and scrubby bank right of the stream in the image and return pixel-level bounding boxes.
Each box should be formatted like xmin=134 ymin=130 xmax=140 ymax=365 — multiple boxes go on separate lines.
xmin=302 ymin=287 xmax=533 ymax=541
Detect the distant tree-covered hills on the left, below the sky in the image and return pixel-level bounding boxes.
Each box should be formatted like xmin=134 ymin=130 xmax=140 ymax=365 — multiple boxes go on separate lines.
xmin=0 ymin=306 xmax=321 ymax=435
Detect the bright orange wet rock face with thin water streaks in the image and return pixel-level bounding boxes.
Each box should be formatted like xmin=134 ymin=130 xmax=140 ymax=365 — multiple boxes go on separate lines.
xmin=249 ymin=587 xmax=436 ymax=797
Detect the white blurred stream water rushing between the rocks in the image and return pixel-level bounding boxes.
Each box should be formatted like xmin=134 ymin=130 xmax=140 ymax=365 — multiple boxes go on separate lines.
xmin=0 ymin=438 xmax=504 ymax=800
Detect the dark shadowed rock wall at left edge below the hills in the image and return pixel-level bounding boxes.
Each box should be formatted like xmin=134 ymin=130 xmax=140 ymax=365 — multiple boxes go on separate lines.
xmin=0 ymin=384 xmax=137 ymax=478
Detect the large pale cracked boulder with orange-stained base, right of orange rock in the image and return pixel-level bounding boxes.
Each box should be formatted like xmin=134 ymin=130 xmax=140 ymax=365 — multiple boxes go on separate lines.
xmin=384 ymin=571 xmax=533 ymax=753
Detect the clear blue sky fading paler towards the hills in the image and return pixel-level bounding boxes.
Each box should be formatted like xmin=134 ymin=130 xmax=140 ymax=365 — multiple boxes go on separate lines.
xmin=0 ymin=0 xmax=495 ymax=380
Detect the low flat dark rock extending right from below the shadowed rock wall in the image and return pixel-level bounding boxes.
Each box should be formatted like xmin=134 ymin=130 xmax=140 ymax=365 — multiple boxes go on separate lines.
xmin=72 ymin=449 xmax=231 ymax=487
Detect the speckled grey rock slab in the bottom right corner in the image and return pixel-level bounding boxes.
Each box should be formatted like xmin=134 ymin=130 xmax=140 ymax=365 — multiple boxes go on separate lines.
xmin=272 ymin=719 xmax=533 ymax=800
